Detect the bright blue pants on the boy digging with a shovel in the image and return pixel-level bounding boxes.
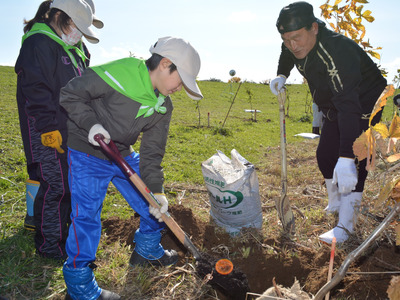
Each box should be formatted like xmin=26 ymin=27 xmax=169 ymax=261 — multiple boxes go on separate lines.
xmin=66 ymin=149 xmax=165 ymax=268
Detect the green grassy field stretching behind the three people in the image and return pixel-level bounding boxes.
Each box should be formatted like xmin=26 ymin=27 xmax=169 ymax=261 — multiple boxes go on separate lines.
xmin=0 ymin=67 xmax=400 ymax=299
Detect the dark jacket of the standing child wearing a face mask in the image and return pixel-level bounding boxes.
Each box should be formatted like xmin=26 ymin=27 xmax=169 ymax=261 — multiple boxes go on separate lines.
xmin=15 ymin=22 xmax=89 ymax=164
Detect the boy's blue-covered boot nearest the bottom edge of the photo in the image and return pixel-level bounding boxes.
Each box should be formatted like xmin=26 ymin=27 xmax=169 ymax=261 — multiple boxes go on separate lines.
xmin=63 ymin=263 xmax=120 ymax=300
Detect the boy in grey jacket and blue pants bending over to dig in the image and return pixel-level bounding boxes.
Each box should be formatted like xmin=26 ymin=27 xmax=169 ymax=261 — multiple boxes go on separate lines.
xmin=60 ymin=37 xmax=203 ymax=299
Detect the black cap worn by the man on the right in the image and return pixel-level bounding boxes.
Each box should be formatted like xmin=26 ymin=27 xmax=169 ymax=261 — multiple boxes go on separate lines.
xmin=276 ymin=1 xmax=318 ymax=34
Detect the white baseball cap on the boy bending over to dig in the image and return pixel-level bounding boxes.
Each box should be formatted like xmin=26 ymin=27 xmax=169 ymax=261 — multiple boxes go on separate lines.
xmin=150 ymin=36 xmax=203 ymax=100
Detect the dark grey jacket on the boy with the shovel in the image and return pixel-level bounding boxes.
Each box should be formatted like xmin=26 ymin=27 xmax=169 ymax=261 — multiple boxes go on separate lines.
xmin=60 ymin=68 xmax=173 ymax=193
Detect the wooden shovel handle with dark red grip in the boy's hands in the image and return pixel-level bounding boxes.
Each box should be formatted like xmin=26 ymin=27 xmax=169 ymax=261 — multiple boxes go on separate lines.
xmin=94 ymin=134 xmax=200 ymax=260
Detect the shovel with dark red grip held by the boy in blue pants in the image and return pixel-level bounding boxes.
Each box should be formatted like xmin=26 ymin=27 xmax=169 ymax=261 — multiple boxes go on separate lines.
xmin=94 ymin=134 xmax=249 ymax=299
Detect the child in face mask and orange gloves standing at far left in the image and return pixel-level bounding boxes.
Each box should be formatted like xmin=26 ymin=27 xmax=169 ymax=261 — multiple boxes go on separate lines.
xmin=15 ymin=0 xmax=99 ymax=261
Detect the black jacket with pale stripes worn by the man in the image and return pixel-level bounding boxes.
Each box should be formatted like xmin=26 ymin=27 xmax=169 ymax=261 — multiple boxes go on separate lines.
xmin=277 ymin=22 xmax=386 ymax=157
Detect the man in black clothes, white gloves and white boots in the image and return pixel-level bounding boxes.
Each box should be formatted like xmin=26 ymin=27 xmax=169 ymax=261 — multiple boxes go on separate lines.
xmin=270 ymin=1 xmax=386 ymax=243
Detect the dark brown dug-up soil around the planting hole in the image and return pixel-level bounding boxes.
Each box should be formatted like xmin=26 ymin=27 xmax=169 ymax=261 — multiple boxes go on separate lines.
xmin=103 ymin=205 xmax=400 ymax=300
